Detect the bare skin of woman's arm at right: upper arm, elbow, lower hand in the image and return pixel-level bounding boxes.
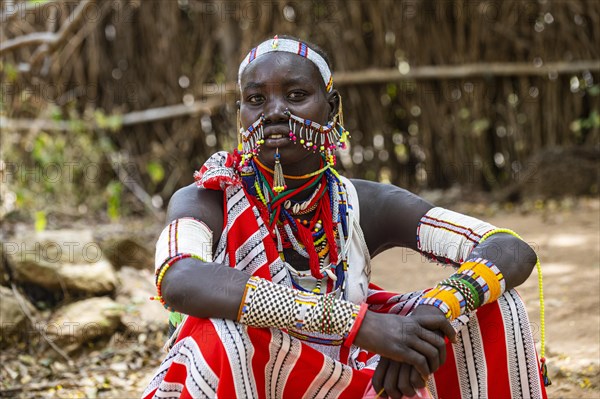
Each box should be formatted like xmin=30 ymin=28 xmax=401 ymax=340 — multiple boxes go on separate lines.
xmin=353 ymin=180 xmax=537 ymax=397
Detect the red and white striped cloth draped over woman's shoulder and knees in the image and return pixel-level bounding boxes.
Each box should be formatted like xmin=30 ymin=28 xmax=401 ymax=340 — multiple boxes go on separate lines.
xmin=143 ymin=153 xmax=546 ymax=399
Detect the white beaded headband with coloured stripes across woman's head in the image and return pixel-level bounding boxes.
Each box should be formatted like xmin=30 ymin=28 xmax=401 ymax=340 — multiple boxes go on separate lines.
xmin=238 ymin=35 xmax=333 ymax=93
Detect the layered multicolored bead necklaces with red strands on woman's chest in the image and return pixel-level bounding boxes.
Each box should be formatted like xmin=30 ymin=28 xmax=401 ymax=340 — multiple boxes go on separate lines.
xmin=242 ymin=159 xmax=348 ymax=290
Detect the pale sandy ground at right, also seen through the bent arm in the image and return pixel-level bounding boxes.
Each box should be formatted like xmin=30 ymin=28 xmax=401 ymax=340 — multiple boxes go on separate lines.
xmin=372 ymin=200 xmax=600 ymax=398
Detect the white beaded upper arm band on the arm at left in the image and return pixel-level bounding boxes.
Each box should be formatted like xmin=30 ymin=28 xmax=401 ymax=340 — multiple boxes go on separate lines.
xmin=151 ymin=217 xmax=212 ymax=310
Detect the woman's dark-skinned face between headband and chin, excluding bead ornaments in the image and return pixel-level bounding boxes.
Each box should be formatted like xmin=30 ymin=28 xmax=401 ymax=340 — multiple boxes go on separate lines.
xmin=240 ymin=52 xmax=335 ymax=169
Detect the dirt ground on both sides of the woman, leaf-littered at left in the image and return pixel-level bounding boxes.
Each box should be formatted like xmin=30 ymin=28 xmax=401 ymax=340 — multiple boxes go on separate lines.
xmin=0 ymin=199 xmax=600 ymax=399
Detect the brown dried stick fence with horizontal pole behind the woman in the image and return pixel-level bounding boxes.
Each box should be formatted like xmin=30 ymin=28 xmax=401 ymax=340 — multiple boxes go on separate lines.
xmin=0 ymin=0 xmax=600 ymax=216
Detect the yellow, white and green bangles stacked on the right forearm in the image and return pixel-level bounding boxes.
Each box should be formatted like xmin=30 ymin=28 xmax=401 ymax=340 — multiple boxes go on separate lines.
xmin=419 ymin=258 xmax=506 ymax=320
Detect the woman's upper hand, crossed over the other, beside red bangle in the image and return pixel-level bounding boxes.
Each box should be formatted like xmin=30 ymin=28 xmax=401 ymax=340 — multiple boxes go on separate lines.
xmin=354 ymin=311 xmax=456 ymax=380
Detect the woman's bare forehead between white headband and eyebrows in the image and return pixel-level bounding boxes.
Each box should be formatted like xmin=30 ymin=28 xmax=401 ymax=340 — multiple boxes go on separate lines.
xmin=240 ymin=52 xmax=324 ymax=90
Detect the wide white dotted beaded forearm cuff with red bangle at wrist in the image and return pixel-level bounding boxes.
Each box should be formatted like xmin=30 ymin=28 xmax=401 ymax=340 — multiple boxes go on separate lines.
xmin=237 ymin=276 xmax=367 ymax=347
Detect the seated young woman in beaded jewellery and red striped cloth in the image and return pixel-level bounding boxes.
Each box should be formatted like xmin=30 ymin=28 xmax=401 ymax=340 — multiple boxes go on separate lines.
xmin=144 ymin=36 xmax=545 ymax=398
